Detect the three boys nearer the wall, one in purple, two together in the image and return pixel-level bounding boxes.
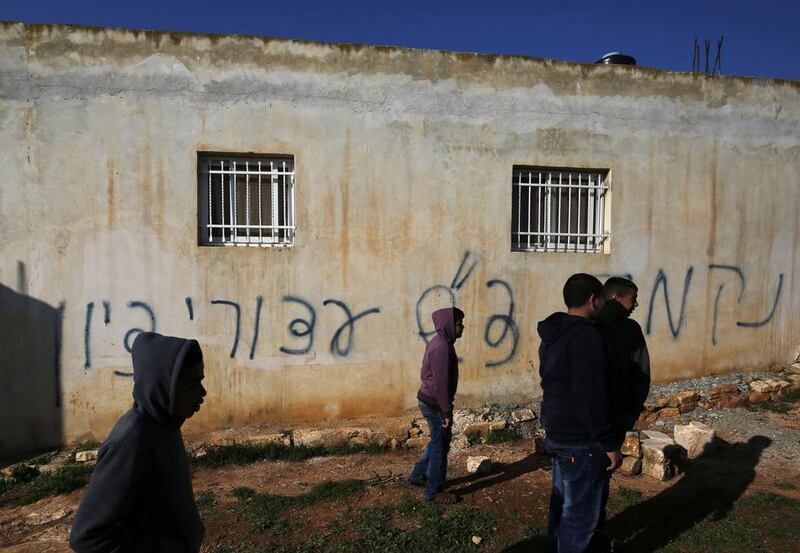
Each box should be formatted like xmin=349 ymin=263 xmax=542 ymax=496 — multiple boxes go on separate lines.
xmin=408 ymin=273 xmax=650 ymax=553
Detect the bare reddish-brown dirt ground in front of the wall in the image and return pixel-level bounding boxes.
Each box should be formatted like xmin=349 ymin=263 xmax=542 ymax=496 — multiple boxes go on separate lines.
xmin=0 ymin=402 xmax=800 ymax=553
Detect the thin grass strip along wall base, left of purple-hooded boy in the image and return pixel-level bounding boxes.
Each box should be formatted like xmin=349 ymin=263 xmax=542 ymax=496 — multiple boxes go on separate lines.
xmin=197 ymin=443 xmax=388 ymax=468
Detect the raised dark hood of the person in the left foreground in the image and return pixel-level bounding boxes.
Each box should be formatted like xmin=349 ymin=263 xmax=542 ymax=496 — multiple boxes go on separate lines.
xmin=131 ymin=332 xmax=200 ymax=426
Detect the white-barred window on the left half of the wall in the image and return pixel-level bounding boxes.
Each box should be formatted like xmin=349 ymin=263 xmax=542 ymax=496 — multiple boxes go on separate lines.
xmin=197 ymin=153 xmax=295 ymax=246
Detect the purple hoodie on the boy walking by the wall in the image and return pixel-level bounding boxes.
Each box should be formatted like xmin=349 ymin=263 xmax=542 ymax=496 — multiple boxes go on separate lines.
xmin=417 ymin=307 xmax=458 ymax=416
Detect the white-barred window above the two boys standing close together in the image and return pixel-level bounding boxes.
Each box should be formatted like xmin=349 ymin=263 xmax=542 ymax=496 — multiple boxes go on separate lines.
xmin=511 ymin=166 xmax=609 ymax=252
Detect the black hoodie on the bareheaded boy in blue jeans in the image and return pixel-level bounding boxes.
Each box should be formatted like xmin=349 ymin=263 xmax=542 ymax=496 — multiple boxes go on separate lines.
xmin=538 ymin=313 xmax=616 ymax=451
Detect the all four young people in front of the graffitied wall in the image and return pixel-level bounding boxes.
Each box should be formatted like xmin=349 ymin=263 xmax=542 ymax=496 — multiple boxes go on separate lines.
xmin=70 ymin=273 xmax=650 ymax=553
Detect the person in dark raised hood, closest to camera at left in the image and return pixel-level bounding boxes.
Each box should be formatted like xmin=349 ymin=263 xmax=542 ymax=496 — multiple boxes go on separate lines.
xmin=69 ymin=332 xmax=206 ymax=553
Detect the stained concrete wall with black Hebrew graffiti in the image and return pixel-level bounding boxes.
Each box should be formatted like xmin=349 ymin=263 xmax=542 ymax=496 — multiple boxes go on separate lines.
xmin=0 ymin=24 xmax=800 ymax=454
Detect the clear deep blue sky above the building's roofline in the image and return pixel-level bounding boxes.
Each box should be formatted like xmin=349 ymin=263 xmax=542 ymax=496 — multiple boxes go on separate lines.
xmin=0 ymin=0 xmax=800 ymax=80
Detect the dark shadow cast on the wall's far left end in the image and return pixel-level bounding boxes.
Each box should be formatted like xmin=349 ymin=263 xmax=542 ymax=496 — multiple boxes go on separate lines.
xmin=0 ymin=263 xmax=64 ymax=460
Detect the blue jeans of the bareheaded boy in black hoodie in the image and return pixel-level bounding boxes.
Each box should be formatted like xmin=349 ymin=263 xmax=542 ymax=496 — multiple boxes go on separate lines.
xmin=545 ymin=439 xmax=609 ymax=553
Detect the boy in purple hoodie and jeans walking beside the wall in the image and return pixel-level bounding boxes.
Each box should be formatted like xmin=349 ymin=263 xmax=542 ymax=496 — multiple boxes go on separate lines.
xmin=408 ymin=307 xmax=464 ymax=504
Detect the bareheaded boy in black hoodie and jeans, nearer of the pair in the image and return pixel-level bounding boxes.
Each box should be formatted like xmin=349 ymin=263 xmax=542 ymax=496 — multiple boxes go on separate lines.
xmin=538 ymin=273 xmax=621 ymax=553
